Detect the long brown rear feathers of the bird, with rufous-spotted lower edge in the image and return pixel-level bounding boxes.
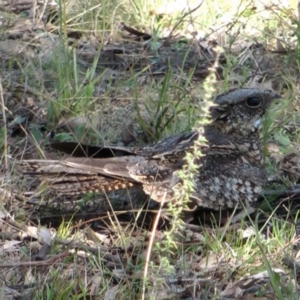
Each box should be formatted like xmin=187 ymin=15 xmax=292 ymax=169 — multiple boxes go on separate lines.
xmin=19 ymin=156 xmax=143 ymax=195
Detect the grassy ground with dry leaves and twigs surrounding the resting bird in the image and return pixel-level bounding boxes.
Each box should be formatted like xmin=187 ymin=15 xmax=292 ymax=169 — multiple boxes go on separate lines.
xmin=0 ymin=0 xmax=300 ymax=299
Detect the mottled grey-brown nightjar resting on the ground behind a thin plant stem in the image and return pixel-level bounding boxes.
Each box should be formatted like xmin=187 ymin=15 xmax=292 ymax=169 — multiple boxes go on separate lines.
xmin=21 ymin=88 xmax=280 ymax=210
